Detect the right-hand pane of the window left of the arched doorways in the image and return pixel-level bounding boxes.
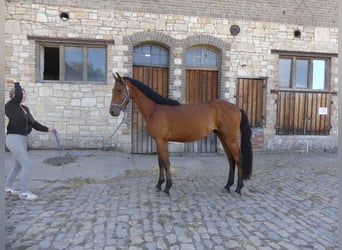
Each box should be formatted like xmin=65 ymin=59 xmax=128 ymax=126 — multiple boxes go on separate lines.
xmin=87 ymin=48 xmax=106 ymax=82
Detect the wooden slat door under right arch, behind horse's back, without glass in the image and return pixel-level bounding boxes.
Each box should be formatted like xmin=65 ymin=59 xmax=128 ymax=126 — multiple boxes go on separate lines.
xmin=185 ymin=70 xmax=218 ymax=153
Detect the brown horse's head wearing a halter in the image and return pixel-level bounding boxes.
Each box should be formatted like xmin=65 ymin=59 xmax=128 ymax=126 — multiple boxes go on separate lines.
xmin=109 ymin=73 xmax=129 ymax=116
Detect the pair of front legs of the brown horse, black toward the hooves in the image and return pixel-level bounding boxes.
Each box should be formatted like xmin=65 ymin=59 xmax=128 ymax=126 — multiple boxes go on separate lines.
xmin=156 ymin=140 xmax=172 ymax=194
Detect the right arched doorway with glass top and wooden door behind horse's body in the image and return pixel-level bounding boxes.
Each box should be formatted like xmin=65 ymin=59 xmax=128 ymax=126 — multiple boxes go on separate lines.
xmin=185 ymin=46 xmax=219 ymax=153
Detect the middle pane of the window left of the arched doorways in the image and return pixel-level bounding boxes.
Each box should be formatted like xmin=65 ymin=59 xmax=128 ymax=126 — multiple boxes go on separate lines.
xmin=65 ymin=47 xmax=83 ymax=81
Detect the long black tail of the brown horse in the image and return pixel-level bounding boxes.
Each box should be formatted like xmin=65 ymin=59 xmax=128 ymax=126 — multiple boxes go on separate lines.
xmin=240 ymin=109 xmax=253 ymax=180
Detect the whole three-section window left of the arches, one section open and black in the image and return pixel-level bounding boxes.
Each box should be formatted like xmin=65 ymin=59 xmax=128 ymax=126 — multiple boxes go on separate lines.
xmin=40 ymin=45 xmax=107 ymax=83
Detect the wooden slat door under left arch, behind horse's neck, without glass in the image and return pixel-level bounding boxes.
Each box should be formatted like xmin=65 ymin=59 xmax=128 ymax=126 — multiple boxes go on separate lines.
xmin=132 ymin=66 xmax=168 ymax=154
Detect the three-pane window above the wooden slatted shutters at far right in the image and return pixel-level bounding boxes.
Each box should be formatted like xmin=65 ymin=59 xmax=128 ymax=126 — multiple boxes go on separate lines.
xmin=279 ymin=56 xmax=330 ymax=90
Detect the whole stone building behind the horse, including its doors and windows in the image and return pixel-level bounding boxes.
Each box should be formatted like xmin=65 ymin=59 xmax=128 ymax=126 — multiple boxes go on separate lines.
xmin=5 ymin=0 xmax=338 ymax=153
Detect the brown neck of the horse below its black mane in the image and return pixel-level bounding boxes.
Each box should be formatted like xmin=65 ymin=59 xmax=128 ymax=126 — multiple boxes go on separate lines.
xmin=130 ymin=86 xmax=157 ymax=121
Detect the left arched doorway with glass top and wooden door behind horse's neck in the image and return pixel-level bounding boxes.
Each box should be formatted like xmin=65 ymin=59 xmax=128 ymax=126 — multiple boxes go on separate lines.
xmin=132 ymin=43 xmax=169 ymax=154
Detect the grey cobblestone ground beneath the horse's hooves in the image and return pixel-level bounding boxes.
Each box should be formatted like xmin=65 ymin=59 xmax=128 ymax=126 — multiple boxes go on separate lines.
xmin=5 ymin=153 xmax=338 ymax=250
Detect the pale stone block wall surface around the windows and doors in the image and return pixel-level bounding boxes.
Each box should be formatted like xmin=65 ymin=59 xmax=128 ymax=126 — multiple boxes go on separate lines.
xmin=5 ymin=0 xmax=338 ymax=151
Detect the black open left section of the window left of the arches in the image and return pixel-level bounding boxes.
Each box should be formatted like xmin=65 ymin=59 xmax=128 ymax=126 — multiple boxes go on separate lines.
xmin=43 ymin=47 xmax=59 ymax=80
